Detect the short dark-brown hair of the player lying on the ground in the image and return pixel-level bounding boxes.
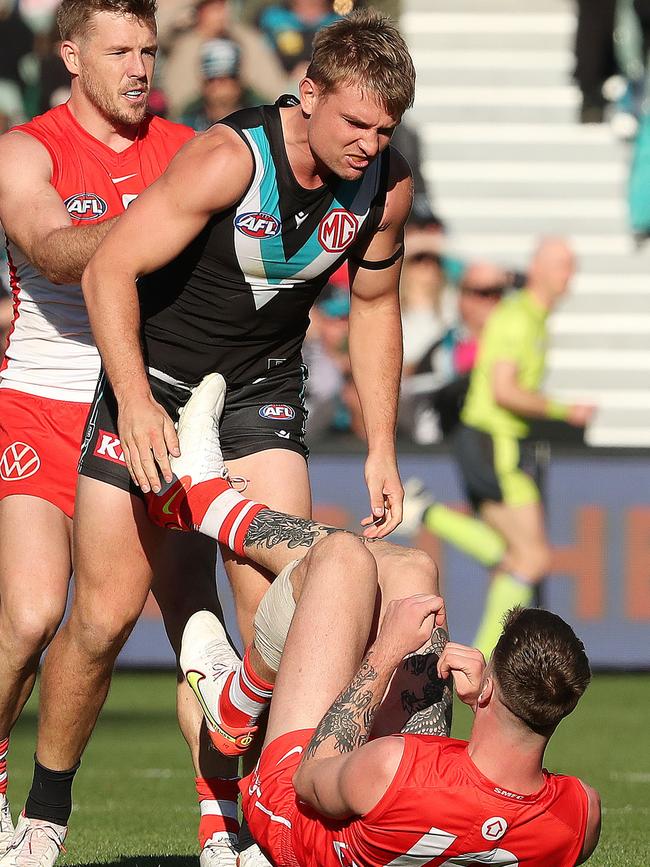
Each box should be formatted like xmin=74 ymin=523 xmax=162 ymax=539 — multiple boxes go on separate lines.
xmin=490 ymin=608 xmax=591 ymax=734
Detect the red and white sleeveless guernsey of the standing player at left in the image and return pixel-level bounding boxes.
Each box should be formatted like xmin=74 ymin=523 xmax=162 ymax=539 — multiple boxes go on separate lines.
xmin=0 ymin=105 xmax=194 ymax=403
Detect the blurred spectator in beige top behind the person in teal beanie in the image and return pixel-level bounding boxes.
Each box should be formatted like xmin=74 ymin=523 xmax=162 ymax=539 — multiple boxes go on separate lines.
xmin=159 ymin=0 xmax=289 ymax=118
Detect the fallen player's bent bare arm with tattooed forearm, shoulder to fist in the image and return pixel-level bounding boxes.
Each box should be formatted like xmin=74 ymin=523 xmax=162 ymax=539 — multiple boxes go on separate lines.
xmin=293 ymin=594 xmax=445 ymax=818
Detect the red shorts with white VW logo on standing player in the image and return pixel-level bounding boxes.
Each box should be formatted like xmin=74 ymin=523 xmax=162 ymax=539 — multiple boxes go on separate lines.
xmin=0 ymin=388 xmax=89 ymax=518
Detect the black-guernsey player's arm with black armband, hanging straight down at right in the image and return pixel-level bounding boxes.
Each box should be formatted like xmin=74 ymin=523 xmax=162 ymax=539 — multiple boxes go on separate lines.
xmin=350 ymin=151 xmax=413 ymax=538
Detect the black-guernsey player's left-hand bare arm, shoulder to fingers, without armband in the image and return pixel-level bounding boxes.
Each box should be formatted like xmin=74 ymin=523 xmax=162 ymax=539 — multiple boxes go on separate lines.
xmin=82 ymin=127 xmax=253 ymax=492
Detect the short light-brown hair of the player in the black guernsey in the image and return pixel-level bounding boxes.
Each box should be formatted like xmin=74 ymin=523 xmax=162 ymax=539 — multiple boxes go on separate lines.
xmin=306 ymin=9 xmax=415 ymax=118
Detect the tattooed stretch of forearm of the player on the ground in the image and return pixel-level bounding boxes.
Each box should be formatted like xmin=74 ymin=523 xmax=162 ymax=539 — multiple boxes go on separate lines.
xmin=305 ymin=650 xmax=390 ymax=759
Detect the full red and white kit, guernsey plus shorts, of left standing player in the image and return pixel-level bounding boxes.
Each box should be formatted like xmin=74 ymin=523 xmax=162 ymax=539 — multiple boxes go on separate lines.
xmin=0 ymin=105 xmax=194 ymax=517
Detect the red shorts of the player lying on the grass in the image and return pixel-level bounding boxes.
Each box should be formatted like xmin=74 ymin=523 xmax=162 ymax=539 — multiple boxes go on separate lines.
xmin=239 ymin=729 xmax=314 ymax=867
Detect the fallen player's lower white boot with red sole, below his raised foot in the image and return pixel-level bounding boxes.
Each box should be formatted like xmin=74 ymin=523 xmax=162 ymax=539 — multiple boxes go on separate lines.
xmin=180 ymin=611 xmax=257 ymax=756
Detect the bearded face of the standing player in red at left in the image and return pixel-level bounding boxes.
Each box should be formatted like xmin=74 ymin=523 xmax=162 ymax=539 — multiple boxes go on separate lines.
xmin=67 ymin=12 xmax=158 ymax=126
